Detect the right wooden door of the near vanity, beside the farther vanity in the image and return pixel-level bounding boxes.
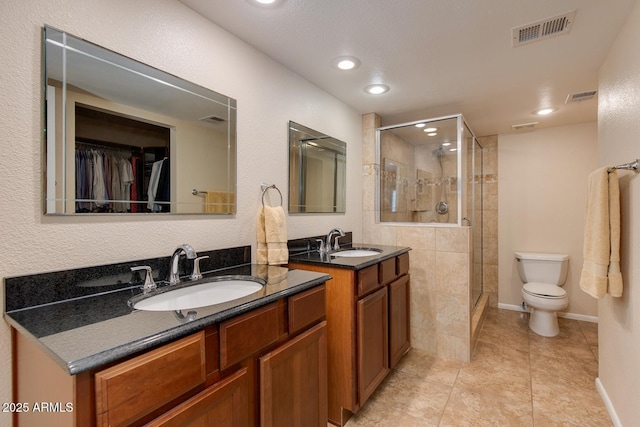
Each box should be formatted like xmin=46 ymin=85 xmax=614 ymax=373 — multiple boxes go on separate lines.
xmin=260 ymin=321 xmax=327 ymax=427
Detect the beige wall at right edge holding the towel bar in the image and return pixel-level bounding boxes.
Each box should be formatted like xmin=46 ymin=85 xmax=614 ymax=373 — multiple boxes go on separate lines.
xmin=598 ymin=2 xmax=640 ymax=427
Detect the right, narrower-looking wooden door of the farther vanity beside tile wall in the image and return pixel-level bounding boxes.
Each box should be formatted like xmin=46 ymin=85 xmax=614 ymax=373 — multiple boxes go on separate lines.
xmin=389 ymin=275 xmax=411 ymax=369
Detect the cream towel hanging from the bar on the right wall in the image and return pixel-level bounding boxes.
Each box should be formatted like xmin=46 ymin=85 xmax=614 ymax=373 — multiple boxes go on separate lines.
xmin=580 ymin=167 xmax=622 ymax=298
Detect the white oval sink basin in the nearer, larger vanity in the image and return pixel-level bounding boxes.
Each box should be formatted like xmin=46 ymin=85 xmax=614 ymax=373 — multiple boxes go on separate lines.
xmin=133 ymin=278 xmax=263 ymax=311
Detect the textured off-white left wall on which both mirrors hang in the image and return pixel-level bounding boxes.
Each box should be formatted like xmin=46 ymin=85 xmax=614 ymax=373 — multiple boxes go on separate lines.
xmin=0 ymin=0 xmax=362 ymax=426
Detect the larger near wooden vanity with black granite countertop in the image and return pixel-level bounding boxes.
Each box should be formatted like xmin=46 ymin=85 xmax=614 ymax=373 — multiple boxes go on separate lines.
xmin=5 ymin=252 xmax=329 ymax=427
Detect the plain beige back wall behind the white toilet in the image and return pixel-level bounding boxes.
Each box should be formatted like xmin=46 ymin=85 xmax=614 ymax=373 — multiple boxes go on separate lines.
xmin=498 ymin=122 xmax=598 ymax=320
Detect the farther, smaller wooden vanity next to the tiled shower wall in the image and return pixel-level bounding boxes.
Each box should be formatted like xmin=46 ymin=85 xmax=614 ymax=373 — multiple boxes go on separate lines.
xmin=289 ymin=245 xmax=410 ymax=426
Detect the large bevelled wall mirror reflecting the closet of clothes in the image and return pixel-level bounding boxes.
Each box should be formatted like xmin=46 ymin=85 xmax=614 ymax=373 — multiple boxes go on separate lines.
xmin=43 ymin=27 xmax=236 ymax=215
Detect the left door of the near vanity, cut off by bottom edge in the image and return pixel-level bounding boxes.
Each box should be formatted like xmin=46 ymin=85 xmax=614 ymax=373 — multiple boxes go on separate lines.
xmin=147 ymin=368 xmax=249 ymax=427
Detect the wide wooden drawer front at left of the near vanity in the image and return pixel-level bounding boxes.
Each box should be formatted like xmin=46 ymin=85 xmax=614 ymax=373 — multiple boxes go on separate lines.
xmin=95 ymin=331 xmax=206 ymax=426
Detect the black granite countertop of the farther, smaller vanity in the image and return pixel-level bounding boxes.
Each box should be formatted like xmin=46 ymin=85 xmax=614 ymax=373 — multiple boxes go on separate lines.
xmin=289 ymin=243 xmax=411 ymax=270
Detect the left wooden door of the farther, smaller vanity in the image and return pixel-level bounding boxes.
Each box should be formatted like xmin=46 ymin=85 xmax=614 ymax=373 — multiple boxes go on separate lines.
xmin=357 ymin=287 xmax=389 ymax=406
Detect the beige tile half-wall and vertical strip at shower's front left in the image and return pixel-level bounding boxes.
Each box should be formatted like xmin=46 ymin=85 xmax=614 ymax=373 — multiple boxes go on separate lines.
xmin=362 ymin=113 xmax=471 ymax=361
